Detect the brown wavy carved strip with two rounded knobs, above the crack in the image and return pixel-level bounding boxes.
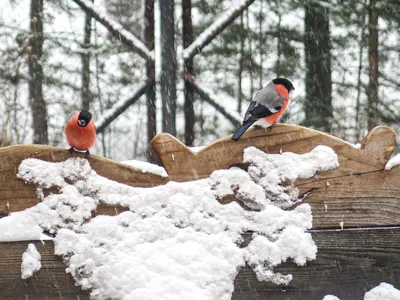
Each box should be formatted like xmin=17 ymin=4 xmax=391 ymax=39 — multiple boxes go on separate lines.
xmin=151 ymin=124 xmax=396 ymax=181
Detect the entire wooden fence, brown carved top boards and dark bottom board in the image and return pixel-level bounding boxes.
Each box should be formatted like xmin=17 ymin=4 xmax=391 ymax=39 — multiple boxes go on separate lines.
xmin=0 ymin=125 xmax=400 ymax=300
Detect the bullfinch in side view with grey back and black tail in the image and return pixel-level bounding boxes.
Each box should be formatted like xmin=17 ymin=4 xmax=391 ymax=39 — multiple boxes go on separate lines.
xmin=232 ymin=78 xmax=294 ymax=141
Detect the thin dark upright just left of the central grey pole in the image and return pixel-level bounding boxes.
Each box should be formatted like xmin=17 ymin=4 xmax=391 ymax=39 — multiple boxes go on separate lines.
xmin=144 ymin=0 xmax=157 ymax=162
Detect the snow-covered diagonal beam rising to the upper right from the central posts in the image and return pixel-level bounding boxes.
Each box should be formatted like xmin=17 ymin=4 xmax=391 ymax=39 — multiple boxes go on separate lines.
xmin=183 ymin=0 xmax=255 ymax=60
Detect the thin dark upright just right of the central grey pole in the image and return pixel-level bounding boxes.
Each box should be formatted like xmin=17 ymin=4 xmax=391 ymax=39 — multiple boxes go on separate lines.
xmin=182 ymin=0 xmax=195 ymax=146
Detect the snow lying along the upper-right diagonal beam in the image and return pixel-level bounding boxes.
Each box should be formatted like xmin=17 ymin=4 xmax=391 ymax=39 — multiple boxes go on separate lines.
xmin=183 ymin=0 xmax=254 ymax=59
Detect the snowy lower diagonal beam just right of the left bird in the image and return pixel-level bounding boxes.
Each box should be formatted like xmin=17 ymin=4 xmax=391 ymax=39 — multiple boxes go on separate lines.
xmin=96 ymin=78 xmax=155 ymax=133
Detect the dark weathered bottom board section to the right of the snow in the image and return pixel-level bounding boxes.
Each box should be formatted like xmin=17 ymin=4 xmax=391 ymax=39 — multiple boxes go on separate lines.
xmin=232 ymin=228 xmax=400 ymax=300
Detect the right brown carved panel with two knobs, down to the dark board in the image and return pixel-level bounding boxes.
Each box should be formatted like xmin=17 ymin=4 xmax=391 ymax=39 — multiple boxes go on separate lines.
xmin=152 ymin=125 xmax=400 ymax=228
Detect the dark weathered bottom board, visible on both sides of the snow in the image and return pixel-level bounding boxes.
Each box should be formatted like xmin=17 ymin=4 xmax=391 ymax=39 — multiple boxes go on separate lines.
xmin=0 ymin=228 xmax=400 ymax=300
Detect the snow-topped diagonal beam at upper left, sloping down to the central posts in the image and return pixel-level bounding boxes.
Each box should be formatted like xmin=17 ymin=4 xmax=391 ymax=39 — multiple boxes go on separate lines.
xmin=72 ymin=0 xmax=154 ymax=61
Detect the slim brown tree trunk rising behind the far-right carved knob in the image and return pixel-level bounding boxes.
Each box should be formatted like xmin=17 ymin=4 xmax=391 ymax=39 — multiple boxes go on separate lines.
xmin=367 ymin=0 xmax=379 ymax=130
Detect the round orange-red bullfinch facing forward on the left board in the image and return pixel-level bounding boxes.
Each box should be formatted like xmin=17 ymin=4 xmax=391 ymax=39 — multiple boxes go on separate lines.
xmin=64 ymin=110 xmax=96 ymax=155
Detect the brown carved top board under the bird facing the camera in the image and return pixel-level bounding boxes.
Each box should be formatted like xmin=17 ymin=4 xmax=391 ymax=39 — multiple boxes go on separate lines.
xmin=0 ymin=145 xmax=168 ymax=217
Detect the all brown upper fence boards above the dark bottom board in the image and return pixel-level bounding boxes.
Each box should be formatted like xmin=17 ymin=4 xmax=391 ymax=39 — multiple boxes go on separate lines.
xmin=0 ymin=125 xmax=400 ymax=228
